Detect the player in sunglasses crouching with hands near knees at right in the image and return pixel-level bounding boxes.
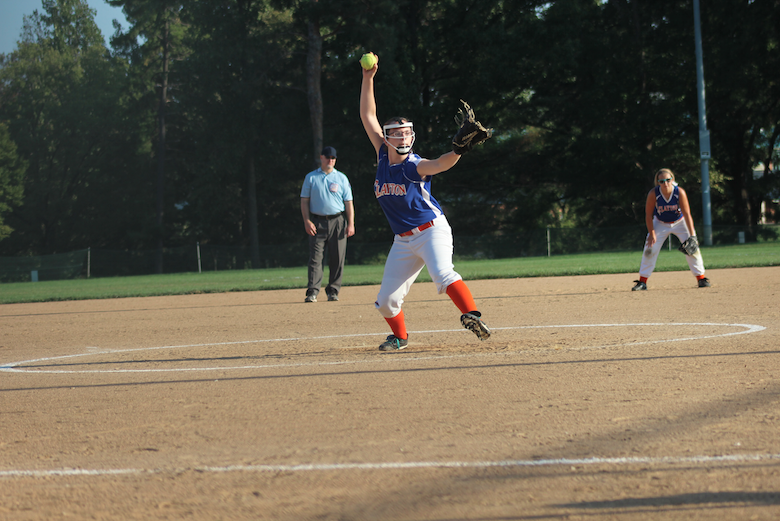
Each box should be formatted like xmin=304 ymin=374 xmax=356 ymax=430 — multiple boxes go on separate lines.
xmin=631 ymin=168 xmax=710 ymax=291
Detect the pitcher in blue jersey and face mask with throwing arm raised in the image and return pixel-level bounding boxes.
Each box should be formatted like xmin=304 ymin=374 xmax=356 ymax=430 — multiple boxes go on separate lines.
xmin=360 ymin=52 xmax=490 ymax=351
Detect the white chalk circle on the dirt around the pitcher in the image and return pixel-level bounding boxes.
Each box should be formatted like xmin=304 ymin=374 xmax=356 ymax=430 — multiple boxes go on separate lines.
xmin=0 ymin=322 xmax=766 ymax=374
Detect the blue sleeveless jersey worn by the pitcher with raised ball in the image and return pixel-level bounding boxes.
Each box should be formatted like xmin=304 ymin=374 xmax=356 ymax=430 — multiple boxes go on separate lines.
xmin=374 ymin=145 xmax=442 ymax=234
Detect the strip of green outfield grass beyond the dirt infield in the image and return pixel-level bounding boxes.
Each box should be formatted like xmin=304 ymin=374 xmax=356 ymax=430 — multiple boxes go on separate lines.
xmin=0 ymin=243 xmax=780 ymax=304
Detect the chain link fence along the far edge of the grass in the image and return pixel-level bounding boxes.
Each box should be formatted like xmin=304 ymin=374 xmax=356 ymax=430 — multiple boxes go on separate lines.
xmin=0 ymin=225 xmax=780 ymax=283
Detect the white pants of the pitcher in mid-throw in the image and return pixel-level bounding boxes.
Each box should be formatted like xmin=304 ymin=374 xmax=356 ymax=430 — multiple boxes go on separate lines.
xmin=374 ymin=215 xmax=462 ymax=318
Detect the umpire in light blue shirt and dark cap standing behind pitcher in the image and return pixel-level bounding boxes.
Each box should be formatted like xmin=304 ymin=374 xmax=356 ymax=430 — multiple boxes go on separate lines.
xmin=301 ymin=147 xmax=355 ymax=302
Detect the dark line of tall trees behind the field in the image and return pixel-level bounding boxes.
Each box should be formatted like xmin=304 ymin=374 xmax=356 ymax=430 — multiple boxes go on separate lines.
xmin=0 ymin=0 xmax=780 ymax=260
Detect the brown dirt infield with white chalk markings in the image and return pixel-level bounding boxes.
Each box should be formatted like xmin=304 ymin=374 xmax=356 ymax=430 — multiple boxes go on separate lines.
xmin=0 ymin=268 xmax=780 ymax=521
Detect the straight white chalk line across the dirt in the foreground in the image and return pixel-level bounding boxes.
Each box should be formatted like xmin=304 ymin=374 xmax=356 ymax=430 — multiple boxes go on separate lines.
xmin=0 ymin=454 xmax=780 ymax=478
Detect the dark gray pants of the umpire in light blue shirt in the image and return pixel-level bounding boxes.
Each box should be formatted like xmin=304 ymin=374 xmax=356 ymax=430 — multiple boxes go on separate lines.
xmin=308 ymin=214 xmax=347 ymax=294
